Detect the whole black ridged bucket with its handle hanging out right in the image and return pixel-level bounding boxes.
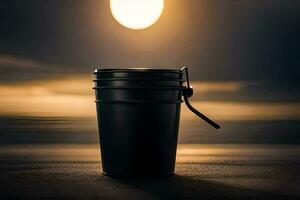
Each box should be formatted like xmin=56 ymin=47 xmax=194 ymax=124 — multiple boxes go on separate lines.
xmin=94 ymin=67 xmax=219 ymax=176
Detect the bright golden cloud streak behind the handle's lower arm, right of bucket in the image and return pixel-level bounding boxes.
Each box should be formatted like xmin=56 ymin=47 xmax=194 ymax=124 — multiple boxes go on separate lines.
xmin=182 ymin=101 xmax=300 ymax=120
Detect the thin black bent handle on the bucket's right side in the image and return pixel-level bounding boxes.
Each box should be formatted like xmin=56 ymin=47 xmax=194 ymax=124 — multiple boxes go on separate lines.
xmin=181 ymin=66 xmax=220 ymax=129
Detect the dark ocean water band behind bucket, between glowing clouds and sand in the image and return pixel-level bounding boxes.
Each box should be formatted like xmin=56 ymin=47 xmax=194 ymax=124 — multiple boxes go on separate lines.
xmin=0 ymin=116 xmax=300 ymax=144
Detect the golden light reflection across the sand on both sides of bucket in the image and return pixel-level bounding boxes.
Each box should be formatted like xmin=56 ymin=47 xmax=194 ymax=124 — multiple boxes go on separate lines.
xmin=0 ymin=144 xmax=300 ymax=163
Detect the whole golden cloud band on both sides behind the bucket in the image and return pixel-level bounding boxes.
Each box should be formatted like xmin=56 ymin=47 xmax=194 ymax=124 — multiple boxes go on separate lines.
xmin=0 ymin=75 xmax=300 ymax=120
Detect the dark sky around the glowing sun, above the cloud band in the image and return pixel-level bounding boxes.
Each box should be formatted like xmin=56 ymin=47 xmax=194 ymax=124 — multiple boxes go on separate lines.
xmin=0 ymin=0 xmax=300 ymax=86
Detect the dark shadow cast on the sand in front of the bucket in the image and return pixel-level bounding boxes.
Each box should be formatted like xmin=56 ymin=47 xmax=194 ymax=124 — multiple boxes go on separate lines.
xmin=109 ymin=175 xmax=296 ymax=200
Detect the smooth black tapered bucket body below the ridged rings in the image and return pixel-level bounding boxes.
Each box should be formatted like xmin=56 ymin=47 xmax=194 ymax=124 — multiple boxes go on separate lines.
xmin=97 ymin=102 xmax=180 ymax=176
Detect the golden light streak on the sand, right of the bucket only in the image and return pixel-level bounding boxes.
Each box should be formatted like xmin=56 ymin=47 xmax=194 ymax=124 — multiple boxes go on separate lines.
xmin=176 ymin=144 xmax=300 ymax=163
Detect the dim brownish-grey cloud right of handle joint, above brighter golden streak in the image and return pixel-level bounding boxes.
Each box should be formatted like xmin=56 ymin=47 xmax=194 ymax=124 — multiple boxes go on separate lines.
xmin=191 ymin=81 xmax=300 ymax=102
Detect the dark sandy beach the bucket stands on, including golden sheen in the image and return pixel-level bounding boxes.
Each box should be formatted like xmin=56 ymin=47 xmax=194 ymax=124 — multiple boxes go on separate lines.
xmin=0 ymin=145 xmax=300 ymax=199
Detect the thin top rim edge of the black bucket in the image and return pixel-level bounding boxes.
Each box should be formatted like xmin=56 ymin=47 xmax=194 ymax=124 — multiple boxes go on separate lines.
xmin=93 ymin=68 xmax=183 ymax=74
